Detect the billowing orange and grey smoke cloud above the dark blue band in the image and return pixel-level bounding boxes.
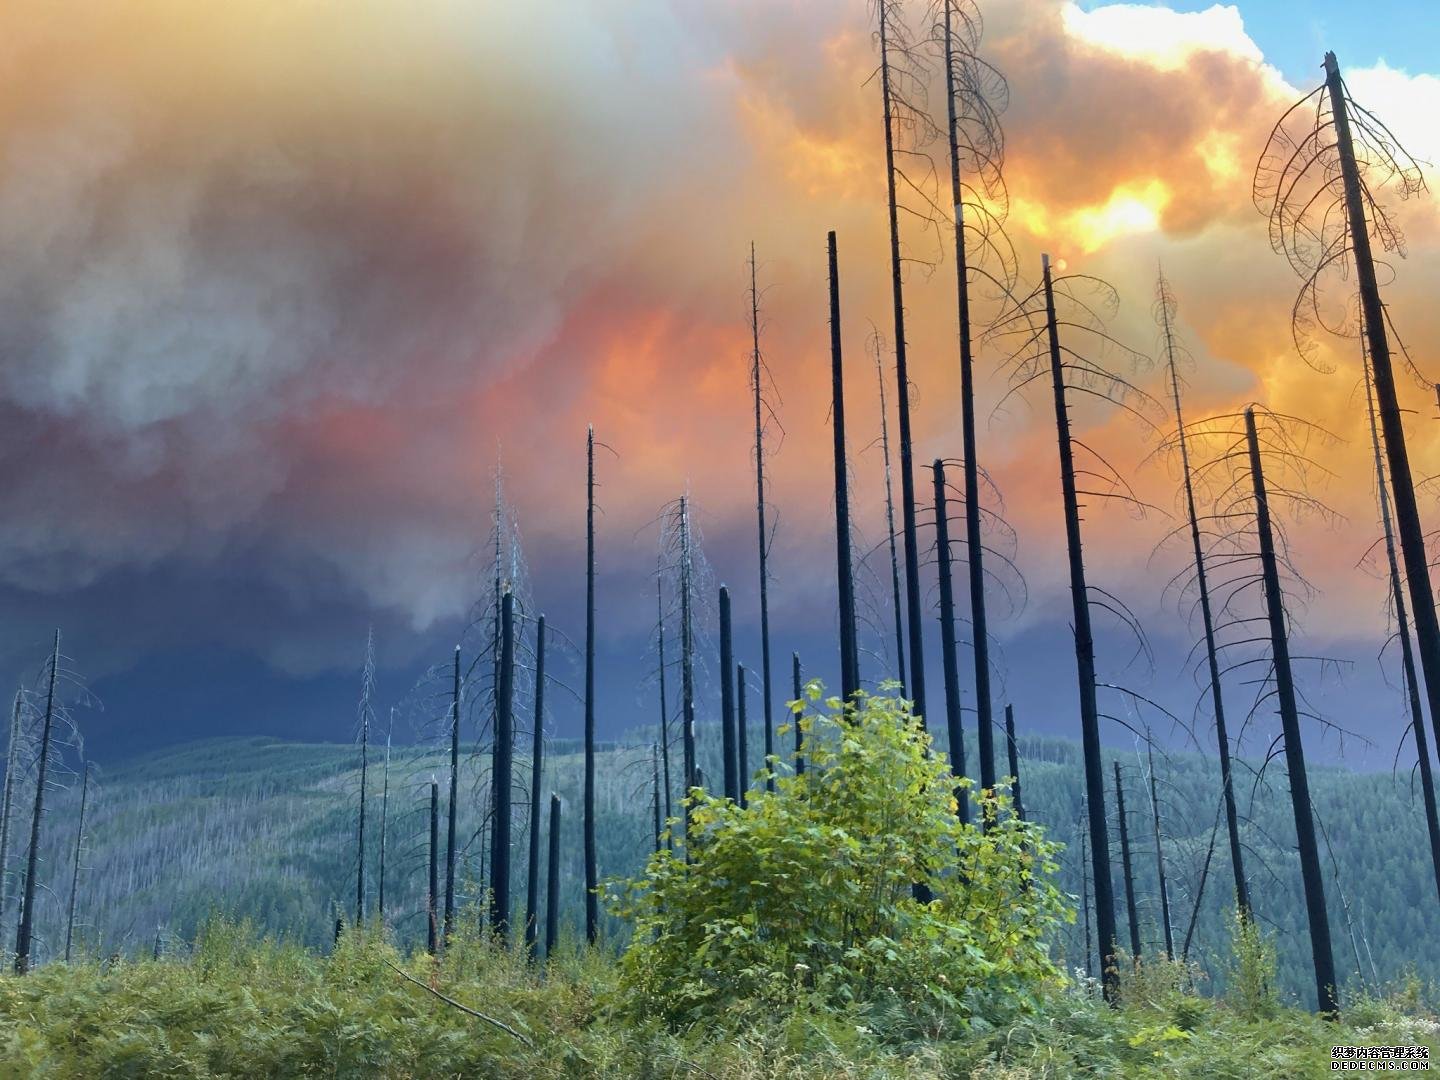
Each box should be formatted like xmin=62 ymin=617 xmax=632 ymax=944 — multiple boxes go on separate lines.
xmin=0 ymin=0 xmax=1440 ymax=722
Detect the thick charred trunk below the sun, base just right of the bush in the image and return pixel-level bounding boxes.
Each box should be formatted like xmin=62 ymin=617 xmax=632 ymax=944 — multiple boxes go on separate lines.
xmin=1043 ymin=255 xmax=1119 ymax=1004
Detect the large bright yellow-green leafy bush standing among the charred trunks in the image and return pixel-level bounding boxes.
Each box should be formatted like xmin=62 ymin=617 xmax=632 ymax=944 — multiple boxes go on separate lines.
xmin=612 ymin=683 xmax=1074 ymax=1034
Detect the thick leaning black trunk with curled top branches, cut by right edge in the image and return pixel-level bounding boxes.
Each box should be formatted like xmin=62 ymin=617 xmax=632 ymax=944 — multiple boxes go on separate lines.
xmin=1325 ymin=52 xmax=1440 ymax=835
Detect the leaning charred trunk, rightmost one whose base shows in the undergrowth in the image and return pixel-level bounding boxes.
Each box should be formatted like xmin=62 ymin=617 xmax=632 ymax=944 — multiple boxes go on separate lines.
xmin=1246 ymin=409 xmax=1339 ymax=1015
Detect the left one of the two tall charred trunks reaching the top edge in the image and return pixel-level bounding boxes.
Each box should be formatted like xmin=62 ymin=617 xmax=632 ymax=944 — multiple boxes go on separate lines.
xmin=878 ymin=3 xmax=927 ymax=723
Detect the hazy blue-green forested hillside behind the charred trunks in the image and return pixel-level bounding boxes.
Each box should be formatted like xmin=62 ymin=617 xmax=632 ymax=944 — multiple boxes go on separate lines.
xmin=22 ymin=729 xmax=1440 ymax=1002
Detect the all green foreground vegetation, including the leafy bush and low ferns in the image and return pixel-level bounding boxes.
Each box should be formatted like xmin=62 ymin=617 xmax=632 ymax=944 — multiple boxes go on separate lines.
xmin=0 ymin=684 xmax=1440 ymax=1080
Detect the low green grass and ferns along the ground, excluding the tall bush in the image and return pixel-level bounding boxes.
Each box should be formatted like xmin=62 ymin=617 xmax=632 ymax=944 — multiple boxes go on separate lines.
xmin=0 ymin=912 xmax=1440 ymax=1080
